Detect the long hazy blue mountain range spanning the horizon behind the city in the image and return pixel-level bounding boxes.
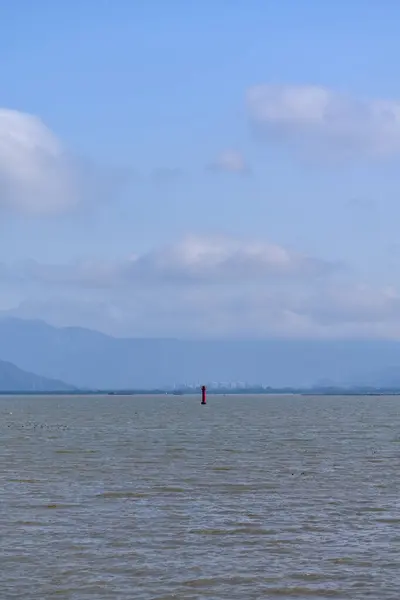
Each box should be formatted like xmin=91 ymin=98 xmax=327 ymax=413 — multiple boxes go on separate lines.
xmin=0 ymin=317 xmax=400 ymax=388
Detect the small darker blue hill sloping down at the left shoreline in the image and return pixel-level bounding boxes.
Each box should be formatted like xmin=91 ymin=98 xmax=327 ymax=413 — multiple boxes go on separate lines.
xmin=0 ymin=360 xmax=74 ymax=392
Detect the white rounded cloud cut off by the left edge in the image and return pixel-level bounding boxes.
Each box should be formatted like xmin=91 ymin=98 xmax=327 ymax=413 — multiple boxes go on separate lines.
xmin=0 ymin=109 xmax=131 ymax=216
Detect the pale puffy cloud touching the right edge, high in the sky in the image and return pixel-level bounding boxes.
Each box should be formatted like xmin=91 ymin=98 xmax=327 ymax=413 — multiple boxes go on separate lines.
xmin=247 ymin=84 xmax=400 ymax=157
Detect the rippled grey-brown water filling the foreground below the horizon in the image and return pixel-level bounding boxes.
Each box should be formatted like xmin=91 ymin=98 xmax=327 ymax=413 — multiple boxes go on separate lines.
xmin=0 ymin=396 xmax=400 ymax=600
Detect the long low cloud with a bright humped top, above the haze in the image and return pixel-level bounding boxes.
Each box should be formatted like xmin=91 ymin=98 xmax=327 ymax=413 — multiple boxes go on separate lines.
xmin=5 ymin=236 xmax=338 ymax=288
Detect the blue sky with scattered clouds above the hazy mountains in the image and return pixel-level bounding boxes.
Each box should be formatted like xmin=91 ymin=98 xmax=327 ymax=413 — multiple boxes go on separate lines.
xmin=0 ymin=0 xmax=400 ymax=339
